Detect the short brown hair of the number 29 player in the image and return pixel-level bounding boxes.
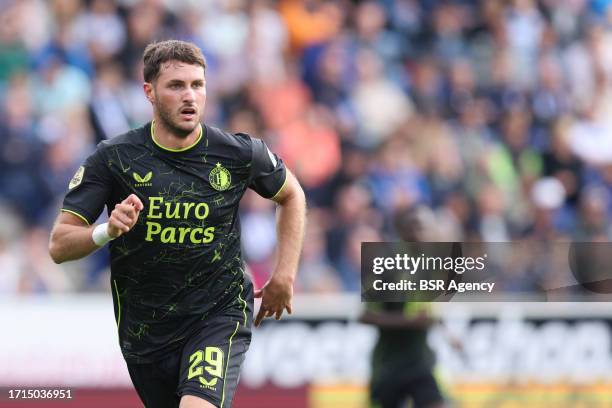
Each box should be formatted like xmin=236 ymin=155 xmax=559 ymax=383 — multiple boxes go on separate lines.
xmin=142 ymin=40 xmax=206 ymax=82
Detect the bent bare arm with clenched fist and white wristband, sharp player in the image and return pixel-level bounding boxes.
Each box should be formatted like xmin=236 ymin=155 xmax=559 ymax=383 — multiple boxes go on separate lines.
xmin=49 ymin=194 xmax=143 ymax=264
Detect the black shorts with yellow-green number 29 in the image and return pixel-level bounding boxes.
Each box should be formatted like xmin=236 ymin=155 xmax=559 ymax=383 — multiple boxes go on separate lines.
xmin=128 ymin=307 xmax=252 ymax=408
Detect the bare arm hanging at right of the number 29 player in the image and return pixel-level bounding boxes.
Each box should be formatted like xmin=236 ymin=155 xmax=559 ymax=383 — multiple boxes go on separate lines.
xmin=255 ymin=170 xmax=306 ymax=326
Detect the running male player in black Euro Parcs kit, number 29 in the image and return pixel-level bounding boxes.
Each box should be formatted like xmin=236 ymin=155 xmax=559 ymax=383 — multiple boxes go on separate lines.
xmin=49 ymin=41 xmax=305 ymax=408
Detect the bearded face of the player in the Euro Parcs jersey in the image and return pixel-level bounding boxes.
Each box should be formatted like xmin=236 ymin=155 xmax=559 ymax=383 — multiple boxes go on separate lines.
xmin=144 ymin=60 xmax=206 ymax=137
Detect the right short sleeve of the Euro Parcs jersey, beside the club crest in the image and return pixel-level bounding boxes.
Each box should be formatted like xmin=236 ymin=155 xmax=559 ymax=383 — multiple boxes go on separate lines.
xmin=249 ymin=138 xmax=287 ymax=198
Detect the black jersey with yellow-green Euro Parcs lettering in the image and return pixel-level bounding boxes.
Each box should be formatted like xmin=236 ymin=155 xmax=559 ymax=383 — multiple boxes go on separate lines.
xmin=62 ymin=123 xmax=286 ymax=362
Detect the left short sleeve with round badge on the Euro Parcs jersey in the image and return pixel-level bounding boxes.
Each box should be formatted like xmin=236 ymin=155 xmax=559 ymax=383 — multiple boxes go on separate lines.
xmin=62 ymin=147 xmax=112 ymax=225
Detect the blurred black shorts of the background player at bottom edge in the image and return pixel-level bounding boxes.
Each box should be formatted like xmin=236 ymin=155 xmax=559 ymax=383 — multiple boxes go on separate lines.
xmin=370 ymin=372 xmax=444 ymax=408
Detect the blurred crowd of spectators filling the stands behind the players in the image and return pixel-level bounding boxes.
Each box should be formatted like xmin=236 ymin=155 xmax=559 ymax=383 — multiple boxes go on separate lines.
xmin=0 ymin=0 xmax=612 ymax=293
